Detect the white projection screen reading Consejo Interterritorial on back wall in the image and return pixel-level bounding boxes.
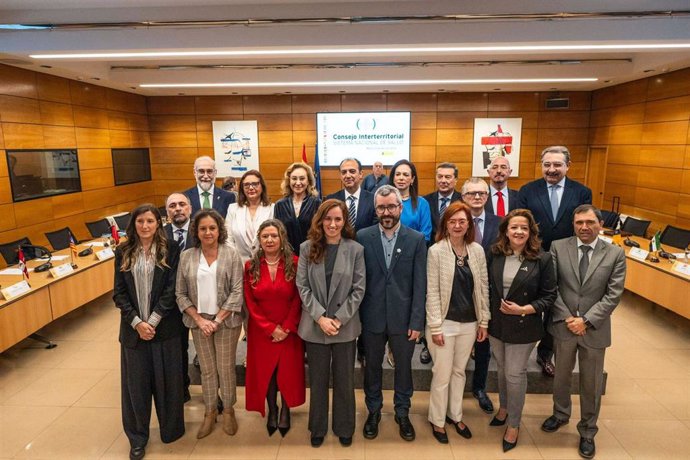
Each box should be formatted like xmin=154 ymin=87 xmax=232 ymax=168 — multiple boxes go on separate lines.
xmin=316 ymin=112 xmax=410 ymax=166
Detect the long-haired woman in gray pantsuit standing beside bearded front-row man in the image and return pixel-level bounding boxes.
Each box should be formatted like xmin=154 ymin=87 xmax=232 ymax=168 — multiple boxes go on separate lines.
xmin=297 ymin=199 xmax=366 ymax=447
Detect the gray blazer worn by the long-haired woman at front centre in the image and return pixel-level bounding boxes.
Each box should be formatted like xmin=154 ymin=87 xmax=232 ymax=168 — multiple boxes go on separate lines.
xmin=296 ymin=238 xmax=366 ymax=344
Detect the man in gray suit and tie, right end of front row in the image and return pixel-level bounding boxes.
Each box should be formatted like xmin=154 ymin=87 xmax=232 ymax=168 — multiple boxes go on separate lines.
xmin=542 ymin=204 xmax=625 ymax=458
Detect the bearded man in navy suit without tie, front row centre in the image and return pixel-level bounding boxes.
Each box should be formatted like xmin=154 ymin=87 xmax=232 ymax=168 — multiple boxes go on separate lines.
xmin=357 ymin=185 xmax=426 ymax=441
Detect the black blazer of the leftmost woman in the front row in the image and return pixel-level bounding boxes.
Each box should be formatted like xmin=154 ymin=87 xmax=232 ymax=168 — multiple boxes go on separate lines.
xmin=113 ymin=241 xmax=186 ymax=348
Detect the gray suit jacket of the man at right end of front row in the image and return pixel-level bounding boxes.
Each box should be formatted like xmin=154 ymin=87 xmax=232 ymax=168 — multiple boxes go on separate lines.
xmin=548 ymin=236 xmax=625 ymax=348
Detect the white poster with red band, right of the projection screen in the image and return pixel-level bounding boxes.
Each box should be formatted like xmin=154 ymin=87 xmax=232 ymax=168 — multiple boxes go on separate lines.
xmin=472 ymin=118 xmax=522 ymax=177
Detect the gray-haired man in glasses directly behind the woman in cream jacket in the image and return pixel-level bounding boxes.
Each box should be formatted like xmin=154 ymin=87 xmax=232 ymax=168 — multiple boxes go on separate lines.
xmin=461 ymin=177 xmax=501 ymax=414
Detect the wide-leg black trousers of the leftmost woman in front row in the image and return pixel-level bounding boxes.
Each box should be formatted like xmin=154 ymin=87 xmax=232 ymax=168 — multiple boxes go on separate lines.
xmin=120 ymin=337 xmax=184 ymax=447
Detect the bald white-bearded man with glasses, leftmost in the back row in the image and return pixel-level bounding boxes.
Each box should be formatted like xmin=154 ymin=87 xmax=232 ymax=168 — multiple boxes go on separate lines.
xmin=184 ymin=156 xmax=235 ymax=217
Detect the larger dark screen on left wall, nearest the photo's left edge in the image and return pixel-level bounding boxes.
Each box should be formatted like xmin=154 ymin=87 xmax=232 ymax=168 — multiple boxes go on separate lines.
xmin=6 ymin=149 xmax=81 ymax=202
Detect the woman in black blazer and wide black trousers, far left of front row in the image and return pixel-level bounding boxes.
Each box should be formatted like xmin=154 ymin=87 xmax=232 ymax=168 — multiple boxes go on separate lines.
xmin=113 ymin=204 xmax=184 ymax=459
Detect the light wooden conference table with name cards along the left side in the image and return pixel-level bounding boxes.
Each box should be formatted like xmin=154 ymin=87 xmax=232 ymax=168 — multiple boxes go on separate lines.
xmin=0 ymin=239 xmax=115 ymax=352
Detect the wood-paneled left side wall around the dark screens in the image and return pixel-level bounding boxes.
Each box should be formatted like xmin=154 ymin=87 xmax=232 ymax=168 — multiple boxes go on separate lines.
xmin=0 ymin=65 xmax=154 ymax=256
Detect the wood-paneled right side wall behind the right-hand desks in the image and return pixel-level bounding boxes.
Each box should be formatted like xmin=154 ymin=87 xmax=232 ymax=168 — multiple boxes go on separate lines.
xmin=590 ymin=69 xmax=690 ymax=232
